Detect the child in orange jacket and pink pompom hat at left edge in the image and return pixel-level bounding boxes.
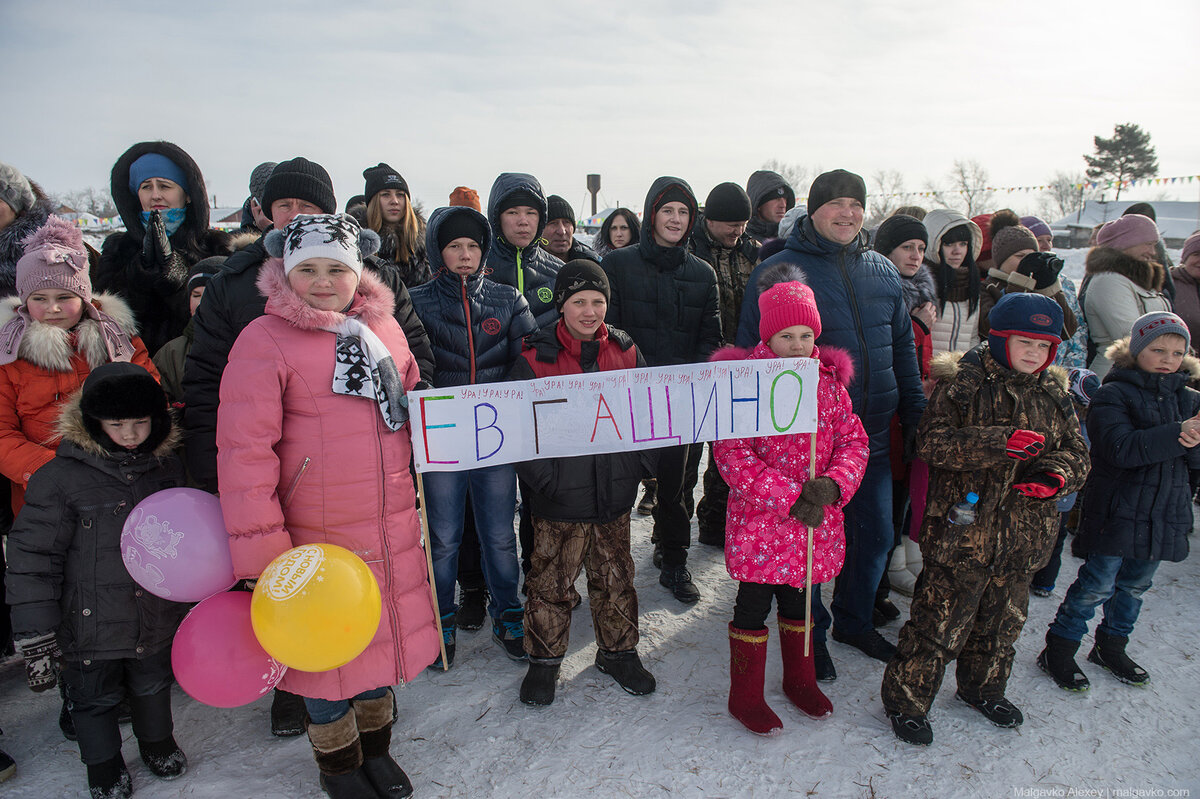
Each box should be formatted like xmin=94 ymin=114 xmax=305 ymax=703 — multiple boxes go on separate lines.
xmin=0 ymin=216 xmax=158 ymax=512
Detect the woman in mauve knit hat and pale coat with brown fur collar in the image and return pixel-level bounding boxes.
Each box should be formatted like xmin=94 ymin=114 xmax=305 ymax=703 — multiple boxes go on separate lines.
xmin=1079 ymin=214 xmax=1171 ymax=380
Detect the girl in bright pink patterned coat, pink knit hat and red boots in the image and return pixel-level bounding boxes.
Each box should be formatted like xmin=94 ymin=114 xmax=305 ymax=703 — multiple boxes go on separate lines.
xmin=713 ymin=264 xmax=868 ymax=735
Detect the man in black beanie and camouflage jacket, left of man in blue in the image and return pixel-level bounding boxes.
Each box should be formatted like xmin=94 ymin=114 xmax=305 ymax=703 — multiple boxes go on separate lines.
xmin=684 ymin=182 xmax=760 ymax=547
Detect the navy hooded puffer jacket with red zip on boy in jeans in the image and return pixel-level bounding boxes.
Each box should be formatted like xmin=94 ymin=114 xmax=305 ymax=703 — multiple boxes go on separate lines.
xmin=413 ymin=206 xmax=538 ymax=388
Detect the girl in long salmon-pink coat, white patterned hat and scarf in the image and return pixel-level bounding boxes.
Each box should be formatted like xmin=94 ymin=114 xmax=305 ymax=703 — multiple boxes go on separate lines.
xmin=217 ymin=215 xmax=438 ymax=797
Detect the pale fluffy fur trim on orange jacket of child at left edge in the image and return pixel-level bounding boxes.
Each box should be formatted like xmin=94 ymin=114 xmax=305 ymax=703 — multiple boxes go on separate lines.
xmin=0 ymin=294 xmax=138 ymax=372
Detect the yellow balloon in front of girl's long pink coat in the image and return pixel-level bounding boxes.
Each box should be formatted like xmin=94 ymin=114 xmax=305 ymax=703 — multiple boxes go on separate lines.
xmin=250 ymin=543 xmax=382 ymax=672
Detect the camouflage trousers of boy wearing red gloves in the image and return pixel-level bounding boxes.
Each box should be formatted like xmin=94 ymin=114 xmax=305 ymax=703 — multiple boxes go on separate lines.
xmin=881 ymin=560 xmax=1032 ymax=716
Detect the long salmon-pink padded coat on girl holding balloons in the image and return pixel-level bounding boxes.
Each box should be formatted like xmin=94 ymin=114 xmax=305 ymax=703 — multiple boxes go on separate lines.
xmin=217 ymin=258 xmax=438 ymax=699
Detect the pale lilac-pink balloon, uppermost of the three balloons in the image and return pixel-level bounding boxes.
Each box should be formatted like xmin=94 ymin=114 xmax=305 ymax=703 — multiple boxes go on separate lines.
xmin=121 ymin=488 xmax=236 ymax=602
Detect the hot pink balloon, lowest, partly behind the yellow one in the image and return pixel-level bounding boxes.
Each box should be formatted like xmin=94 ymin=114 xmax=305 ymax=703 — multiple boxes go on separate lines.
xmin=170 ymin=591 xmax=288 ymax=708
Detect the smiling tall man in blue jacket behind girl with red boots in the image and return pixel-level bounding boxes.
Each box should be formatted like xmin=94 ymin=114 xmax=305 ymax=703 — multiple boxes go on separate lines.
xmin=737 ymin=169 xmax=925 ymax=681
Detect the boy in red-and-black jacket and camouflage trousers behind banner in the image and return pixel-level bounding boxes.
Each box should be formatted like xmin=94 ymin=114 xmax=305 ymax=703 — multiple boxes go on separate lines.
xmin=509 ymin=258 xmax=655 ymax=704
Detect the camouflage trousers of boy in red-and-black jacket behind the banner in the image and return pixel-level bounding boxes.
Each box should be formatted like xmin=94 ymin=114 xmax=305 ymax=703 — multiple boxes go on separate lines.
xmin=524 ymin=513 xmax=637 ymax=660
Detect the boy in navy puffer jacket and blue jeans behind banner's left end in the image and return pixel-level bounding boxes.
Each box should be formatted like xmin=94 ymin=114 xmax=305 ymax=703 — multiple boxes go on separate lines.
xmin=413 ymin=206 xmax=537 ymax=667
